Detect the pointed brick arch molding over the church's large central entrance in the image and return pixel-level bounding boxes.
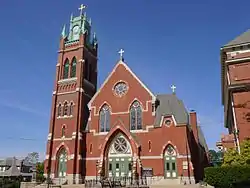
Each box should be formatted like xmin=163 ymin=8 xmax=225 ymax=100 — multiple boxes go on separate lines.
xmin=101 ymin=125 xmax=140 ymax=158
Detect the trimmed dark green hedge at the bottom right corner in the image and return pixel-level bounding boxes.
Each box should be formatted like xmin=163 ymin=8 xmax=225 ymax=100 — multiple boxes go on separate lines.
xmin=205 ymin=165 xmax=250 ymax=188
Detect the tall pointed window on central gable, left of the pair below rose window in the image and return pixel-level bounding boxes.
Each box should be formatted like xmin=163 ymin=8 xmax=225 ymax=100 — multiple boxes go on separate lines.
xmin=99 ymin=105 xmax=110 ymax=132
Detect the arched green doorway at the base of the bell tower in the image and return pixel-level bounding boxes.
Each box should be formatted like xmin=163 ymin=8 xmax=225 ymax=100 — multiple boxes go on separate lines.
xmin=57 ymin=148 xmax=67 ymax=178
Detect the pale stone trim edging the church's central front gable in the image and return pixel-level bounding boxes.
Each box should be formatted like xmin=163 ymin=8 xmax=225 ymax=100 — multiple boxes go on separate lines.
xmin=88 ymin=60 xmax=155 ymax=109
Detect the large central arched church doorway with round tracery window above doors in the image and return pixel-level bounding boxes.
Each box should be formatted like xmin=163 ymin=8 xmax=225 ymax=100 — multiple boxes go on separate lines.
xmin=106 ymin=134 xmax=133 ymax=177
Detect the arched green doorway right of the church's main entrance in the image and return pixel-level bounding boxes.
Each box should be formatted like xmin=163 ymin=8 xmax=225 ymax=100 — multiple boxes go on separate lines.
xmin=164 ymin=145 xmax=178 ymax=179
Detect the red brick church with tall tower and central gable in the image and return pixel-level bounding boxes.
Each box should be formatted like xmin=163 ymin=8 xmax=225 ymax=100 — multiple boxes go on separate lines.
xmin=45 ymin=6 xmax=208 ymax=184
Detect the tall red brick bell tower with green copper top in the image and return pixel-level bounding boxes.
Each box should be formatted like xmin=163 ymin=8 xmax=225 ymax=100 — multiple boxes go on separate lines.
xmin=44 ymin=5 xmax=98 ymax=184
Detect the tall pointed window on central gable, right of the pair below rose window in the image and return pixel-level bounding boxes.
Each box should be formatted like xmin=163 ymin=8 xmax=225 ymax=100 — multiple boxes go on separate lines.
xmin=130 ymin=101 xmax=142 ymax=130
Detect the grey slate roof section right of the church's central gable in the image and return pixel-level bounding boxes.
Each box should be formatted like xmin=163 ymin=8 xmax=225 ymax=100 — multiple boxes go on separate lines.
xmin=154 ymin=94 xmax=189 ymax=126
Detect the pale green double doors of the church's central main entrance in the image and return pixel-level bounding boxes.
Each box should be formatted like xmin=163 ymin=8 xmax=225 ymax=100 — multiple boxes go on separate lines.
xmin=108 ymin=157 xmax=132 ymax=177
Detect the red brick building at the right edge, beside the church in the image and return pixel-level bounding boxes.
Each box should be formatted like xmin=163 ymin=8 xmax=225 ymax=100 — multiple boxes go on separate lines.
xmin=217 ymin=30 xmax=250 ymax=153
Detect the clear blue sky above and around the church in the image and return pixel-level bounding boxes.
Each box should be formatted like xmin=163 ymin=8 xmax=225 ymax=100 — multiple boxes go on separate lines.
xmin=0 ymin=0 xmax=250 ymax=158
